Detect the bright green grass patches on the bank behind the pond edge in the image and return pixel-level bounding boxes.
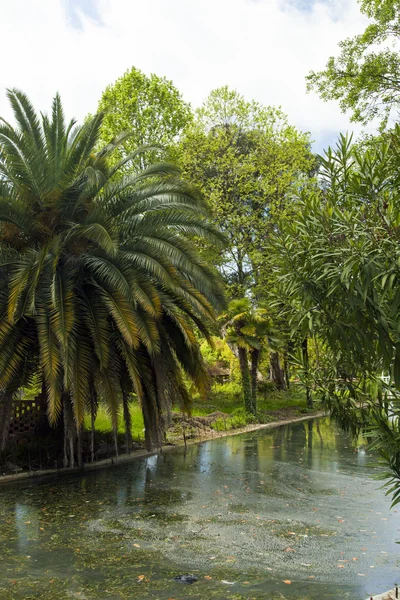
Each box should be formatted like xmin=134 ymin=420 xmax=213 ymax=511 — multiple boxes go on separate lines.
xmin=85 ymin=382 xmax=307 ymax=442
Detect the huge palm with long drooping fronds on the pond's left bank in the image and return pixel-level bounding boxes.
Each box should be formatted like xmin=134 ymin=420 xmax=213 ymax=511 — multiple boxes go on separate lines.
xmin=0 ymin=90 xmax=223 ymax=464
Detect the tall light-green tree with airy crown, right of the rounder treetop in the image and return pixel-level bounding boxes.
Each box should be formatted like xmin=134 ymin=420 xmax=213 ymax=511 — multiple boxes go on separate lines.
xmin=176 ymin=87 xmax=314 ymax=297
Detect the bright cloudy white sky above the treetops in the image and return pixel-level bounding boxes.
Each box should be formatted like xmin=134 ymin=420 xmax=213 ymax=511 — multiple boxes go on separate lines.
xmin=0 ymin=0 xmax=366 ymax=151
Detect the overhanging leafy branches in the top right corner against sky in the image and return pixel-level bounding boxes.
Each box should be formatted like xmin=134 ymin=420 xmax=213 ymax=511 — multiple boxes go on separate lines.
xmin=307 ymin=0 xmax=400 ymax=125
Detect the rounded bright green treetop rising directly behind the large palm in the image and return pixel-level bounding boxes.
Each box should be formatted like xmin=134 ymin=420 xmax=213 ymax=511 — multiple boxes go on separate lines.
xmin=98 ymin=67 xmax=192 ymax=168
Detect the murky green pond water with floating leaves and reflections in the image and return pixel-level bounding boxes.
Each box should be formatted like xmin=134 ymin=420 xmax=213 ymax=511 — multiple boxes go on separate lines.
xmin=0 ymin=419 xmax=400 ymax=600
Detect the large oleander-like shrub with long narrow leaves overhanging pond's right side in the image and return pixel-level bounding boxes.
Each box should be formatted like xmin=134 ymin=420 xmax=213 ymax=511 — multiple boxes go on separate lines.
xmin=275 ymin=131 xmax=400 ymax=502
